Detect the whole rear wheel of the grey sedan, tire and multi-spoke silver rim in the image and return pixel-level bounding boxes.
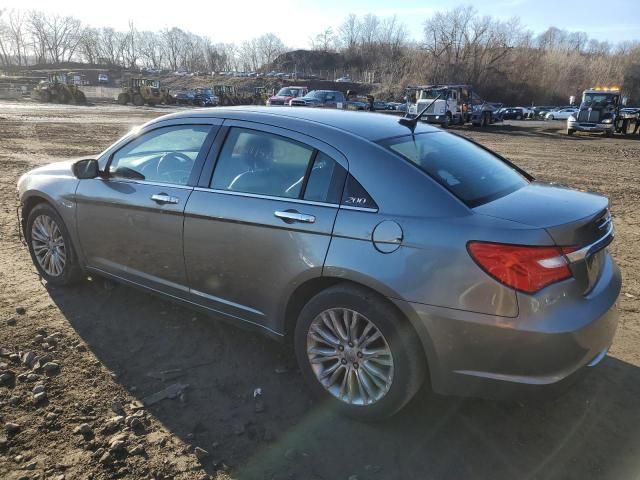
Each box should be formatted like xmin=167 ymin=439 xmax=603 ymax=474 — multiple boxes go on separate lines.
xmin=295 ymin=284 xmax=426 ymax=419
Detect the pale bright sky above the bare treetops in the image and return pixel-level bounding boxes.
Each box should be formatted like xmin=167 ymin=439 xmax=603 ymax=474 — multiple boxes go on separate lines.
xmin=5 ymin=0 xmax=640 ymax=48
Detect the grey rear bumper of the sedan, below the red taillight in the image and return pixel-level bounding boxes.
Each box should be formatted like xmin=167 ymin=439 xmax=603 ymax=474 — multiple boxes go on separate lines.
xmin=396 ymin=251 xmax=621 ymax=398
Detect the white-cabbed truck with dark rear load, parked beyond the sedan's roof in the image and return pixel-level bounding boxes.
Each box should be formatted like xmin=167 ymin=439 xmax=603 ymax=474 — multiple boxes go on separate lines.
xmin=406 ymin=84 xmax=500 ymax=128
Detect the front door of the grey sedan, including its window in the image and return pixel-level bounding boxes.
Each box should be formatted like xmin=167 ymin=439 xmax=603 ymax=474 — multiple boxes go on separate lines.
xmin=76 ymin=120 xmax=221 ymax=295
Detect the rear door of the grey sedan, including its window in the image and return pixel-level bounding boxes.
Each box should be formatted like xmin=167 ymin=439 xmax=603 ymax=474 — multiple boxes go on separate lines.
xmin=184 ymin=121 xmax=347 ymax=333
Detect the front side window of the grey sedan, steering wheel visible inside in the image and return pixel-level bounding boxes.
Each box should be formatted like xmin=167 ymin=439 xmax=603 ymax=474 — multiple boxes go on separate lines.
xmin=109 ymin=125 xmax=211 ymax=185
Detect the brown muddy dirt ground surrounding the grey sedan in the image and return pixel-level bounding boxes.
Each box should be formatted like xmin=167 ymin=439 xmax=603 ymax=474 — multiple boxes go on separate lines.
xmin=0 ymin=102 xmax=640 ymax=480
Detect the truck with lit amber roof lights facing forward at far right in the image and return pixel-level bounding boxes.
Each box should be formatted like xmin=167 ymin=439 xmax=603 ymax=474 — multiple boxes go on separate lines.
xmin=567 ymin=87 xmax=634 ymax=136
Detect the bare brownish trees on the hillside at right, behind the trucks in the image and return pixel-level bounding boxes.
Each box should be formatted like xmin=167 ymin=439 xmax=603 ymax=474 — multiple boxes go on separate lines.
xmin=311 ymin=6 xmax=640 ymax=105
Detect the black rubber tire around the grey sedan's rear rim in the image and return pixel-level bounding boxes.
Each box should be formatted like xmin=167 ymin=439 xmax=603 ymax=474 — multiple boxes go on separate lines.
xmin=294 ymin=283 xmax=426 ymax=420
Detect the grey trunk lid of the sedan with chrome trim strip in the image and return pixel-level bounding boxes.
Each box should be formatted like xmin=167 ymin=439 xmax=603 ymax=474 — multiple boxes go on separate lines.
xmin=473 ymin=182 xmax=613 ymax=293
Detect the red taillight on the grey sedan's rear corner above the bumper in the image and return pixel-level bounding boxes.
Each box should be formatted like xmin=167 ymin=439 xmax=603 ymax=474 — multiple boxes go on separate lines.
xmin=467 ymin=242 xmax=575 ymax=293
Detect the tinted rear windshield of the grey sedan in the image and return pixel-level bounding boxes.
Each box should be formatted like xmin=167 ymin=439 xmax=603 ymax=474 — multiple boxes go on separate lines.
xmin=381 ymin=132 xmax=529 ymax=207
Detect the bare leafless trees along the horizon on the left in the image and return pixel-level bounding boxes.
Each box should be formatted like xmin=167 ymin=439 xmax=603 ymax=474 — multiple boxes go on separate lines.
xmin=0 ymin=9 xmax=286 ymax=72
